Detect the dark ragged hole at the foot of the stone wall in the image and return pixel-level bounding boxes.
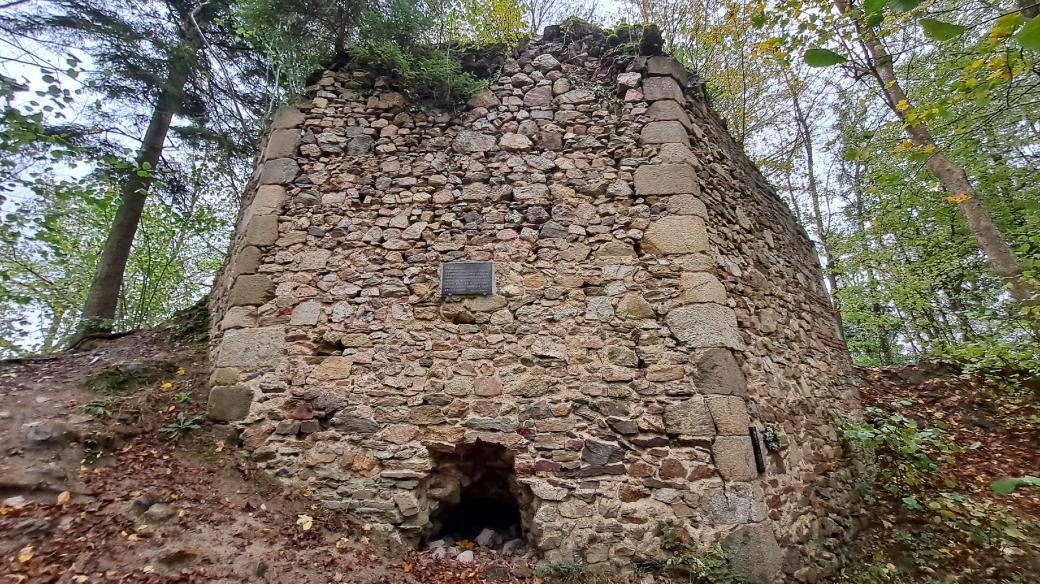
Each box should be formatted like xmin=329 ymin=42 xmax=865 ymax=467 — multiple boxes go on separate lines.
xmin=425 ymin=442 xmax=530 ymax=548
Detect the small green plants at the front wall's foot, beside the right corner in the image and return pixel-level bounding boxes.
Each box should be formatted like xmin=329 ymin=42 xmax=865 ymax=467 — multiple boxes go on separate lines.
xmin=638 ymin=521 xmax=746 ymax=584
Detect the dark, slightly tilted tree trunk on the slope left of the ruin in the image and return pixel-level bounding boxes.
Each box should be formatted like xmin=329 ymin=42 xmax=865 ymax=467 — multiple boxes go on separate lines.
xmin=80 ymin=23 xmax=202 ymax=334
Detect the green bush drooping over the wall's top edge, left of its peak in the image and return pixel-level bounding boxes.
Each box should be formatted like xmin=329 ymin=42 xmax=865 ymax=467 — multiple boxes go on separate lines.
xmin=347 ymin=42 xmax=488 ymax=104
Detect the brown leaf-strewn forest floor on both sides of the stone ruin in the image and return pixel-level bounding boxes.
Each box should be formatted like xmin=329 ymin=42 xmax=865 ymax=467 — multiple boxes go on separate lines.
xmin=0 ymin=317 xmax=1040 ymax=584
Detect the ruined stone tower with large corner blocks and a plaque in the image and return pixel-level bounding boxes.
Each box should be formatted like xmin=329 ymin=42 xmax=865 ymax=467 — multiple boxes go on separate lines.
xmin=202 ymin=24 xmax=858 ymax=582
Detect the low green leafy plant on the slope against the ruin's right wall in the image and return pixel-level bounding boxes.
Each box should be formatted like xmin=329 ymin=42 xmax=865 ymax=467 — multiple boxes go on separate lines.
xmin=840 ymin=402 xmax=962 ymax=495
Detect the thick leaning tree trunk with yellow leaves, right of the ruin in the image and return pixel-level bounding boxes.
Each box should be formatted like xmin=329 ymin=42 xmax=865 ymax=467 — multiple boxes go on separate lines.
xmin=835 ymin=0 xmax=1040 ymax=331
